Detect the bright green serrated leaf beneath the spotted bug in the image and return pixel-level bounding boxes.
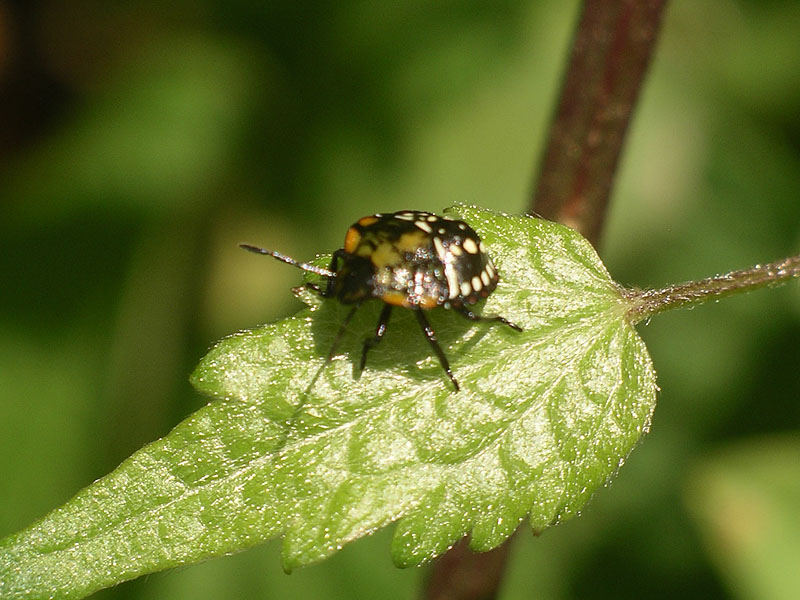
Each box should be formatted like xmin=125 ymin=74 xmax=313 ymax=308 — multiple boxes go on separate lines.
xmin=0 ymin=207 xmax=656 ymax=598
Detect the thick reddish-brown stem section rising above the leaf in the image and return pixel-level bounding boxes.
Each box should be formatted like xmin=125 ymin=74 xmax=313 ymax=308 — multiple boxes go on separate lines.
xmin=531 ymin=0 xmax=666 ymax=247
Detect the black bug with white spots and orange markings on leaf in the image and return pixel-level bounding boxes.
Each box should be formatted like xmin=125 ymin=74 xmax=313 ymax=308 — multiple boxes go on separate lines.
xmin=240 ymin=210 xmax=522 ymax=391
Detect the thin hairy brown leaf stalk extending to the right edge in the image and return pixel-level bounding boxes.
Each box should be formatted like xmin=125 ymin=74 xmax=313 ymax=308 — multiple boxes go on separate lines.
xmin=626 ymin=254 xmax=800 ymax=323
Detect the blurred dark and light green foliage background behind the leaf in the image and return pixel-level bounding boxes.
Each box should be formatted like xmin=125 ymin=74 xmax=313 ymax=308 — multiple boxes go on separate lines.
xmin=0 ymin=0 xmax=800 ymax=600
